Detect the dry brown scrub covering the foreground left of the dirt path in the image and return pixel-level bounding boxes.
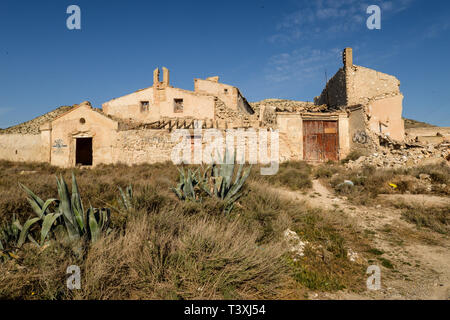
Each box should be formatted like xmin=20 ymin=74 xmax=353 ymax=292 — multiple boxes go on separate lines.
xmin=0 ymin=162 xmax=376 ymax=299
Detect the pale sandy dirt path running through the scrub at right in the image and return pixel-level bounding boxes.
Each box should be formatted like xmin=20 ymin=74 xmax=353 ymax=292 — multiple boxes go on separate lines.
xmin=270 ymin=180 xmax=450 ymax=299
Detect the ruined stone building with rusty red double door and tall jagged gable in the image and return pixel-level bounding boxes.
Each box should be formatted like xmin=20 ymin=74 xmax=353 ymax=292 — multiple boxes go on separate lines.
xmin=255 ymin=48 xmax=405 ymax=162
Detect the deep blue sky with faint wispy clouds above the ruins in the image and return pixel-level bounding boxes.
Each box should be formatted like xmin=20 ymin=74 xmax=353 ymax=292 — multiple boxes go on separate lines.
xmin=0 ymin=0 xmax=450 ymax=128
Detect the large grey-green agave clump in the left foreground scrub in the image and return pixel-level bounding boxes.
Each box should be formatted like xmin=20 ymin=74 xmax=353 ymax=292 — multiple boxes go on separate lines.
xmin=14 ymin=173 xmax=110 ymax=247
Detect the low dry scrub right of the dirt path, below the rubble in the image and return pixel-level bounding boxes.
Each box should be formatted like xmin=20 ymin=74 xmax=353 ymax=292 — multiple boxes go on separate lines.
xmin=313 ymin=162 xmax=450 ymax=234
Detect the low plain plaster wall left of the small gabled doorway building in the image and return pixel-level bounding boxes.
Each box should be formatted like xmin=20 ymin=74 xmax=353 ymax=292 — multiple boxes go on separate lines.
xmin=0 ymin=134 xmax=46 ymax=162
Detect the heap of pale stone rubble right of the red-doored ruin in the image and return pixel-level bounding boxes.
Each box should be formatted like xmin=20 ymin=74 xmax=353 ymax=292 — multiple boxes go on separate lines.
xmin=345 ymin=136 xmax=450 ymax=169
